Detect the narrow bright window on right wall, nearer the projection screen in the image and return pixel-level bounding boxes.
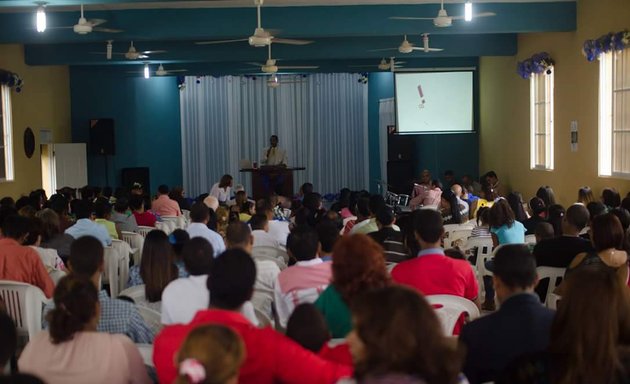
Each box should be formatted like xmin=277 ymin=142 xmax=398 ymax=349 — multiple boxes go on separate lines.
xmin=530 ymin=67 xmax=553 ymax=170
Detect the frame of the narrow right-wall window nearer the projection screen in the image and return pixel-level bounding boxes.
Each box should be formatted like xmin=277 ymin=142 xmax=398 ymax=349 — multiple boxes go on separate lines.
xmin=529 ymin=67 xmax=554 ymax=171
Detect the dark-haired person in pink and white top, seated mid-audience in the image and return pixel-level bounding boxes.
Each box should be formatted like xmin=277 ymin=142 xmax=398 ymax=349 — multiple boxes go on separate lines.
xmin=274 ymin=225 xmax=332 ymax=327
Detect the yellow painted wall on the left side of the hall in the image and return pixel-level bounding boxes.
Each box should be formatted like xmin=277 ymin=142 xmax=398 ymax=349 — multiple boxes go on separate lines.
xmin=0 ymin=45 xmax=71 ymax=198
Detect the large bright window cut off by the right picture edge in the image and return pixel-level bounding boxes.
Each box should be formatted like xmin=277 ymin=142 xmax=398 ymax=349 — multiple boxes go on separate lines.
xmin=599 ymin=49 xmax=630 ymax=178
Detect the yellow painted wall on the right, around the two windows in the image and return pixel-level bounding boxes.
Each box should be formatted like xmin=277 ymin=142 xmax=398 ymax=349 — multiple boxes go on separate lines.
xmin=480 ymin=0 xmax=630 ymax=206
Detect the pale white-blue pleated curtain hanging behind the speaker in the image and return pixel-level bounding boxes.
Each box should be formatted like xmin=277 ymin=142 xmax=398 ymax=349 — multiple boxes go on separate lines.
xmin=180 ymin=73 xmax=369 ymax=196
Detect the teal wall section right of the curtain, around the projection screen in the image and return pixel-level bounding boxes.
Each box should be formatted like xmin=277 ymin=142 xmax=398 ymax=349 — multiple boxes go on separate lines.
xmin=368 ymin=58 xmax=483 ymax=192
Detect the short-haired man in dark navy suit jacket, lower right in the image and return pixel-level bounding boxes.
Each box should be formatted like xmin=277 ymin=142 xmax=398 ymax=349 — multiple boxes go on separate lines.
xmin=459 ymin=244 xmax=554 ymax=384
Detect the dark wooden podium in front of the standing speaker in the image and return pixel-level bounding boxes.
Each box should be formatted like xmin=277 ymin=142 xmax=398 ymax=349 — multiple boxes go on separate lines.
xmin=241 ymin=166 xmax=306 ymax=200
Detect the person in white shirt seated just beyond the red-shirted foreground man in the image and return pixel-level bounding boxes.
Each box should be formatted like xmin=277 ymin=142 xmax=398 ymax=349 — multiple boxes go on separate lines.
xmin=162 ymin=237 xmax=258 ymax=325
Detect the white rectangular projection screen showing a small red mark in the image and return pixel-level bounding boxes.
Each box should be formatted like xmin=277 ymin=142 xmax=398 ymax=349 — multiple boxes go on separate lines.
xmin=395 ymin=72 xmax=473 ymax=134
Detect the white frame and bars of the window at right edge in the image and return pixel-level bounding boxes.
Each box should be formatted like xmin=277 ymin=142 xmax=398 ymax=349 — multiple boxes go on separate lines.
xmin=597 ymin=49 xmax=630 ymax=180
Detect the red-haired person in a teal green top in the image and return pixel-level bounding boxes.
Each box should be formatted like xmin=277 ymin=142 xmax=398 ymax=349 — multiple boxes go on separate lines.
xmin=315 ymin=232 xmax=390 ymax=338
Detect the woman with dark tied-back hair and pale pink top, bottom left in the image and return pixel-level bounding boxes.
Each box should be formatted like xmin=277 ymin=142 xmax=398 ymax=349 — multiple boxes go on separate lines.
xmin=18 ymin=276 xmax=151 ymax=384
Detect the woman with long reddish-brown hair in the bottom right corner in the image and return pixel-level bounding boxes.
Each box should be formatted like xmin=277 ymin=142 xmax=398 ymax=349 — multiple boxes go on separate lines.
xmin=496 ymin=263 xmax=630 ymax=384
